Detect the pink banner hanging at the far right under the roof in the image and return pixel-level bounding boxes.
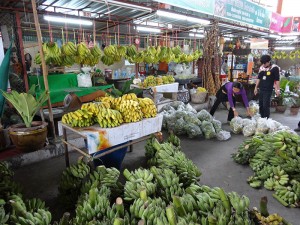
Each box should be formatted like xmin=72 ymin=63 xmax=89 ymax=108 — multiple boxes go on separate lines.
xmin=270 ymin=12 xmax=292 ymax=33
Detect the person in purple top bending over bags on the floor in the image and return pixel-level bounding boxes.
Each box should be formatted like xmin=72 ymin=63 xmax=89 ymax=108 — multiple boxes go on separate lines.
xmin=210 ymin=82 xmax=250 ymax=121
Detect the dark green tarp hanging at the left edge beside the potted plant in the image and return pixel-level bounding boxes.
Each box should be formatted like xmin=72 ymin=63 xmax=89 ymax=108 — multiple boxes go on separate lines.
xmin=0 ymin=44 xmax=11 ymax=118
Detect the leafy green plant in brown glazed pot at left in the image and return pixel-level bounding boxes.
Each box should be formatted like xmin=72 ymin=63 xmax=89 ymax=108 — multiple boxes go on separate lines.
xmin=0 ymin=85 xmax=48 ymax=152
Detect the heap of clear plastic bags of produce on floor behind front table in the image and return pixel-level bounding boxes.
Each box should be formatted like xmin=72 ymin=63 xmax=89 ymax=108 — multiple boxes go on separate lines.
xmin=160 ymin=101 xmax=231 ymax=140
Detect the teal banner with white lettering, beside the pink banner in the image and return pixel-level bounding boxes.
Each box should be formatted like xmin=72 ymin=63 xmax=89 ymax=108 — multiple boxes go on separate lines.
xmin=214 ymin=0 xmax=271 ymax=29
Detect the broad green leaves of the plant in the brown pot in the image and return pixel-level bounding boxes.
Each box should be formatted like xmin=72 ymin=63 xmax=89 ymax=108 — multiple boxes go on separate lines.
xmin=0 ymin=85 xmax=49 ymax=127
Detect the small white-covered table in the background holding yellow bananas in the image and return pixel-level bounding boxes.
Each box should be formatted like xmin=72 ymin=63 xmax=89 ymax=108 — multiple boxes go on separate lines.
xmin=130 ymin=82 xmax=179 ymax=105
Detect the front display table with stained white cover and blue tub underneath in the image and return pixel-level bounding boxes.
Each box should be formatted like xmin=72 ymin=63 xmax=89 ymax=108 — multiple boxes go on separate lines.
xmin=58 ymin=115 xmax=163 ymax=167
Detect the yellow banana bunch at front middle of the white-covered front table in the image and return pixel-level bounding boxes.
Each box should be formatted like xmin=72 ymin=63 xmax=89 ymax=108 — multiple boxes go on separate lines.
xmin=97 ymin=108 xmax=123 ymax=128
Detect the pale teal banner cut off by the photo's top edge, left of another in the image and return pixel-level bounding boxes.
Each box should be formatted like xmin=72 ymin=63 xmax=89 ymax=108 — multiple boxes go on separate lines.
xmin=155 ymin=0 xmax=215 ymax=15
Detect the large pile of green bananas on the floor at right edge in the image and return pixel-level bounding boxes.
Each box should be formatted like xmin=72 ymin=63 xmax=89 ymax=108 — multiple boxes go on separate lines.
xmin=233 ymin=131 xmax=300 ymax=207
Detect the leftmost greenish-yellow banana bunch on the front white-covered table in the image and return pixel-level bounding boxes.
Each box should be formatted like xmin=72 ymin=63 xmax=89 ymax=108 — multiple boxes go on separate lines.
xmin=61 ymin=109 xmax=94 ymax=127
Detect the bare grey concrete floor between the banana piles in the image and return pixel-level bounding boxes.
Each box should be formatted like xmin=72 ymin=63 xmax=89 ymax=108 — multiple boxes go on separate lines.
xmin=15 ymin=108 xmax=300 ymax=225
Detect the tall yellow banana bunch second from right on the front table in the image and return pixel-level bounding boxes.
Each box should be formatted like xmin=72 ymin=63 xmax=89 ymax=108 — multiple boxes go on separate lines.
xmin=119 ymin=100 xmax=143 ymax=123
